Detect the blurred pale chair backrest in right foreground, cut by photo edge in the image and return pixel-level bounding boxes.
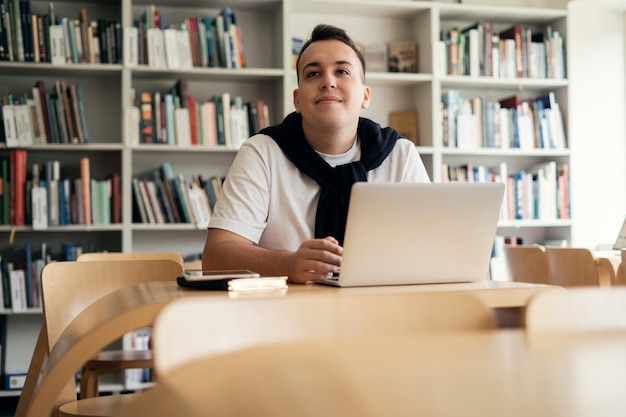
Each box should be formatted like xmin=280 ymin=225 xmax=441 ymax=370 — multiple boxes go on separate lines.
xmin=525 ymin=287 xmax=626 ymax=333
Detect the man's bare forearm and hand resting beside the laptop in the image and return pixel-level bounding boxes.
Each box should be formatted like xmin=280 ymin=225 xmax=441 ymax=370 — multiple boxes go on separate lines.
xmin=202 ymin=229 xmax=343 ymax=283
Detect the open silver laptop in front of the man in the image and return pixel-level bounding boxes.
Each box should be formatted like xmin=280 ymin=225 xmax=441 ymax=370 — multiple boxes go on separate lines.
xmin=320 ymin=182 xmax=504 ymax=287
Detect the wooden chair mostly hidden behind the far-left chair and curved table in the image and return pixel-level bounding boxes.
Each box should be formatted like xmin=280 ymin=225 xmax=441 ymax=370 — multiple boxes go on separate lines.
xmin=76 ymin=252 xmax=183 ymax=399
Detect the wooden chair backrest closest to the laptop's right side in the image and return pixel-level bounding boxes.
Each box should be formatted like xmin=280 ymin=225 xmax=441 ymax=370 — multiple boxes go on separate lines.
xmin=504 ymin=245 xmax=552 ymax=284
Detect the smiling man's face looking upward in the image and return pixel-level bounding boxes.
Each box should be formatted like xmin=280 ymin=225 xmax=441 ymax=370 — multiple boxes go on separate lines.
xmin=293 ymin=40 xmax=370 ymax=129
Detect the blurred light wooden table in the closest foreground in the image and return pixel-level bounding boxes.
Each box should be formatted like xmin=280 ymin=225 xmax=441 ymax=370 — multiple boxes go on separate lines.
xmin=118 ymin=329 xmax=626 ymax=417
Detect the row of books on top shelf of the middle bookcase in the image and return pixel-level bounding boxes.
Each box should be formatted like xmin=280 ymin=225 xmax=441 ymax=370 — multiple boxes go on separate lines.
xmin=124 ymin=5 xmax=246 ymax=69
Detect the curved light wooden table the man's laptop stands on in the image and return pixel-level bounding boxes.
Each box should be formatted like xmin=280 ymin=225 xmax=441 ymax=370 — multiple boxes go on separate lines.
xmin=27 ymin=281 xmax=563 ymax=417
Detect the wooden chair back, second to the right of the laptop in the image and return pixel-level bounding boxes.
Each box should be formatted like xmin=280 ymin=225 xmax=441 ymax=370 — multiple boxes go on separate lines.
xmin=546 ymin=246 xmax=615 ymax=287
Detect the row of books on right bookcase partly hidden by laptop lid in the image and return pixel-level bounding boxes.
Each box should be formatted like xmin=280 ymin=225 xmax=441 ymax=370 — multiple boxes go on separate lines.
xmin=442 ymin=161 xmax=570 ymax=220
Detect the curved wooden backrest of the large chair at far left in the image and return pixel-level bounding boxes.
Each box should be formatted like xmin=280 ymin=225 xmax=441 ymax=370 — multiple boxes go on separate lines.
xmin=39 ymin=259 xmax=183 ymax=404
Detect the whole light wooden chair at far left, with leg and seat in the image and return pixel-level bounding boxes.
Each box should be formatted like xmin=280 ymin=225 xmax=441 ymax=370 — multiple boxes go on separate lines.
xmin=15 ymin=259 xmax=183 ymax=417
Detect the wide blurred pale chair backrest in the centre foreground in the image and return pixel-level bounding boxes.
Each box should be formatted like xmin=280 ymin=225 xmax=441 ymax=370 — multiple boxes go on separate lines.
xmin=153 ymin=293 xmax=495 ymax=376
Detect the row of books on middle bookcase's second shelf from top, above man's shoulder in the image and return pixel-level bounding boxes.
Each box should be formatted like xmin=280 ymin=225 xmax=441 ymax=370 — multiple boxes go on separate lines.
xmin=127 ymin=80 xmax=269 ymax=149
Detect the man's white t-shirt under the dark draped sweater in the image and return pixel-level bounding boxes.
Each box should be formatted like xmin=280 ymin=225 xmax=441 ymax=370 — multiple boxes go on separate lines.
xmin=209 ymin=134 xmax=430 ymax=251
